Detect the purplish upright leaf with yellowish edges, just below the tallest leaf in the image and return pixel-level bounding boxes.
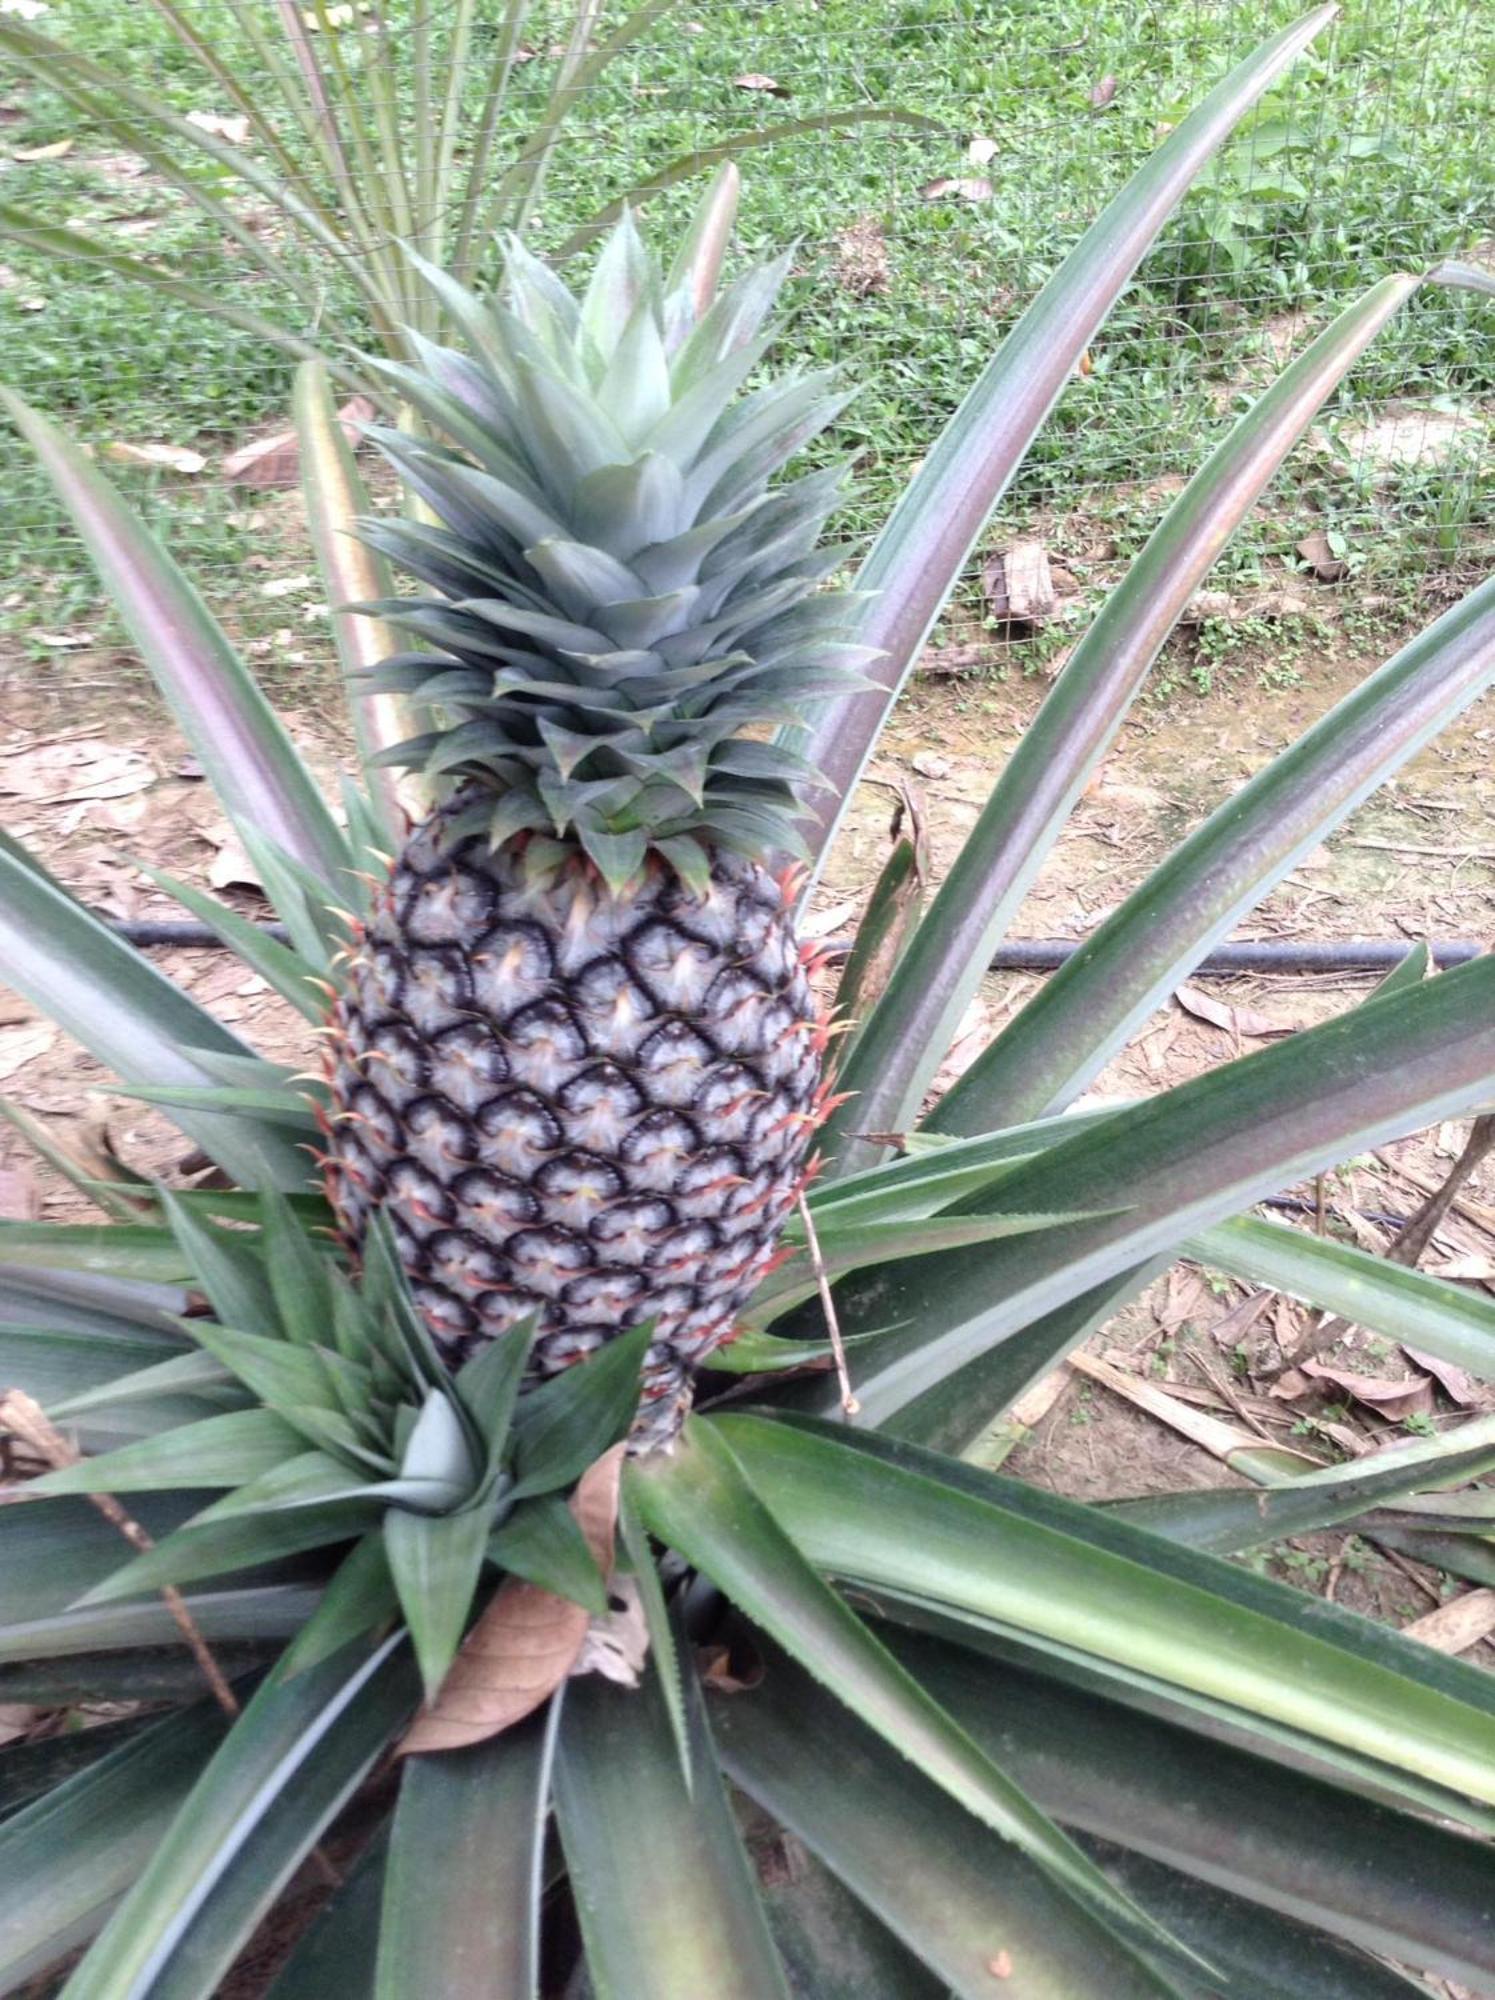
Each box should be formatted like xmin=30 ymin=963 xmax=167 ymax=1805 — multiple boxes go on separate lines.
xmin=821 ymin=278 xmax=1419 ymax=1174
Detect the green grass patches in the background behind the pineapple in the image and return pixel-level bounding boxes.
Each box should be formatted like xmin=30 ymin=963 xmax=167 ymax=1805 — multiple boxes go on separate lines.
xmin=0 ymin=0 xmax=1495 ymax=676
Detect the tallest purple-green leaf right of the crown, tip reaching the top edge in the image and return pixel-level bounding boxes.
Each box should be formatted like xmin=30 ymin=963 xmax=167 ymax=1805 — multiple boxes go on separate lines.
xmin=793 ymin=6 xmax=1335 ymax=854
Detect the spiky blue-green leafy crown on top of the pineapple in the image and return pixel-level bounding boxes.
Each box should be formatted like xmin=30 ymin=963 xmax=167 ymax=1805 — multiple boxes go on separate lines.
xmin=362 ymin=190 xmax=873 ymax=892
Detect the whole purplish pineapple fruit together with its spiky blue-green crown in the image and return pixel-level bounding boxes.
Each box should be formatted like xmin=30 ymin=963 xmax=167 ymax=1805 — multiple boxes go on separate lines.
xmin=326 ymin=195 xmax=865 ymax=1450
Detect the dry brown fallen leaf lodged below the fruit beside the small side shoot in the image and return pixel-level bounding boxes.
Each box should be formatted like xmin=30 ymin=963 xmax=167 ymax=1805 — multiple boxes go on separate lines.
xmin=400 ymin=1444 xmax=626 ymax=1756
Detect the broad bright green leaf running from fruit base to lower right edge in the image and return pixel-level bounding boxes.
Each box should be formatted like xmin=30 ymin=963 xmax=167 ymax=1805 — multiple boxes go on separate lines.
xmin=714 ymin=1416 xmax=1495 ymax=1802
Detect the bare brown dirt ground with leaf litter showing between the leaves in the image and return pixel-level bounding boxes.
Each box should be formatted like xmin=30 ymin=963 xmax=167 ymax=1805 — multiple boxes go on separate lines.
xmin=0 ymin=620 xmax=1495 ymax=1662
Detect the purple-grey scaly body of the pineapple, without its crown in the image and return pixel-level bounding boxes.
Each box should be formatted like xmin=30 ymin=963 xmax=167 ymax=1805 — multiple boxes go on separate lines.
xmin=326 ymin=800 xmax=825 ymax=1450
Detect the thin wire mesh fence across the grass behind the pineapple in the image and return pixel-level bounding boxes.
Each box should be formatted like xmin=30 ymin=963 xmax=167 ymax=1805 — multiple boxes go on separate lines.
xmin=0 ymin=0 xmax=1495 ymax=666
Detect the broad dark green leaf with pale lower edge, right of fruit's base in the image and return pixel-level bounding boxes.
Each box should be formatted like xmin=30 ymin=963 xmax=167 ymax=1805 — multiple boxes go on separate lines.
xmin=827 ymin=958 xmax=1495 ymax=1424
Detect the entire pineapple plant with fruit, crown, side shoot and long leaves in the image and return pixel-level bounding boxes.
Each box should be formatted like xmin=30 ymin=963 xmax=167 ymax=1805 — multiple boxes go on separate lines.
xmin=0 ymin=10 xmax=1495 ymax=2000
